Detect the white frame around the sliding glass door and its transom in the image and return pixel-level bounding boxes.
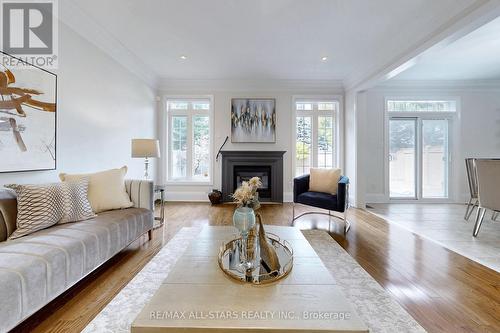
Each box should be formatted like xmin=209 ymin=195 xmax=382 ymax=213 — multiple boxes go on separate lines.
xmin=384 ymin=94 xmax=461 ymax=203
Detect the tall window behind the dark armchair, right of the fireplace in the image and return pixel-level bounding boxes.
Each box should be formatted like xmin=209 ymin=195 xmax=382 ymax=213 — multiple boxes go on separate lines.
xmin=295 ymin=99 xmax=339 ymax=176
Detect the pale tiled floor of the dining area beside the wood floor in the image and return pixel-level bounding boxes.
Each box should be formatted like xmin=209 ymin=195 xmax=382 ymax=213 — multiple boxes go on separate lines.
xmin=368 ymin=203 xmax=500 ymax=272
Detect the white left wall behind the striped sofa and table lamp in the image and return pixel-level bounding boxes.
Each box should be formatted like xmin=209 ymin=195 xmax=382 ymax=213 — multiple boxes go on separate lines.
xmin=0 ymin=24 xmax=156 ymax=184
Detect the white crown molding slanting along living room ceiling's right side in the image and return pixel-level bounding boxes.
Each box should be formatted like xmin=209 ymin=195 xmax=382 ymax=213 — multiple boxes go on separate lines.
xmin=344 ymin=0 xmax=500 ymax=91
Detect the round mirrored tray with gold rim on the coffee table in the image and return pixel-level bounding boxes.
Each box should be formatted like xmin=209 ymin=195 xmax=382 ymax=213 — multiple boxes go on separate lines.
xmin=218 ymin=233 xmax=293 ymax=285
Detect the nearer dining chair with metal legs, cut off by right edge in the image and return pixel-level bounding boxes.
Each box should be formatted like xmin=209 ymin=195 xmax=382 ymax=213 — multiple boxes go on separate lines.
xmin=472 ymin=159 xmax=500 ymax=237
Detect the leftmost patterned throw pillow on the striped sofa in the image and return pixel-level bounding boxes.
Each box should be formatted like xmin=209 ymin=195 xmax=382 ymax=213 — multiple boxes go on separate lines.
xmin=5 ymin=184 xmax=63 ymax=239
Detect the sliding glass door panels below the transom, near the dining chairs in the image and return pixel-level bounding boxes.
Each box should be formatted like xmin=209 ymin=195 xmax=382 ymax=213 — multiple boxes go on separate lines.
xmin=389 ymin=117 xmax=450 ymax=199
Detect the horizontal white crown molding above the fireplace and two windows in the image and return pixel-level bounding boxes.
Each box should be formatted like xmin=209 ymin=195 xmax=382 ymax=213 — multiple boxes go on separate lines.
xmin=158 ymin=78 xmax=344 ymax=93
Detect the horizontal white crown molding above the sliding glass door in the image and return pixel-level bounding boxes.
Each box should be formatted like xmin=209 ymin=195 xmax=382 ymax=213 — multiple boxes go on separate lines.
xmin=370 ymin=80 xmax=500 ymax=90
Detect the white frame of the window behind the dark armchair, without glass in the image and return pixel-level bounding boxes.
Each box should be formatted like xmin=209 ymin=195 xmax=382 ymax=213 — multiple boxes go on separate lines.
xmin=291 ymin=95 xmax=344 ymax=181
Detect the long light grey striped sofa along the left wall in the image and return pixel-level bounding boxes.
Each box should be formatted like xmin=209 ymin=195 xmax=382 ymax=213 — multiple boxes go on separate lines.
xmin=0 ymin=180 xmax=154 ymax=332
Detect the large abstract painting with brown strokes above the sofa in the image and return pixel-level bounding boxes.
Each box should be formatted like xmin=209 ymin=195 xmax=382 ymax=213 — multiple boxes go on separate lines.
xmin=0 ymin=51 xmax=57 ymax=172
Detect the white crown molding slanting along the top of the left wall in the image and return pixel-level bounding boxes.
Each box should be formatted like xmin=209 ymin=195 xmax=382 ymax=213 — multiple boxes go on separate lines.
xmin=59 ymin=0 xmax=158 ymax=89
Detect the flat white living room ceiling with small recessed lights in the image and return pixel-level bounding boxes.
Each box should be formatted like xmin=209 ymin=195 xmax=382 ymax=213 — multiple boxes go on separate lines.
xmin=60 ymin=0 xmax=480 ymax=84
